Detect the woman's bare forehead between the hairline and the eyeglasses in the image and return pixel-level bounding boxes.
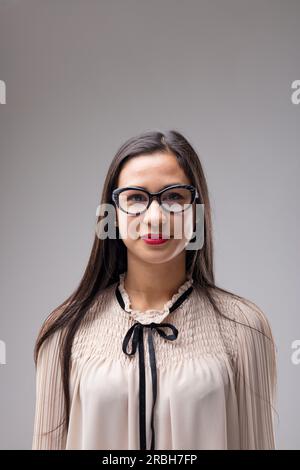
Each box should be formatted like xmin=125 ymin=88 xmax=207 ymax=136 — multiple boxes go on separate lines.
xmin=118 ymin=152 xmax=190 ymax=191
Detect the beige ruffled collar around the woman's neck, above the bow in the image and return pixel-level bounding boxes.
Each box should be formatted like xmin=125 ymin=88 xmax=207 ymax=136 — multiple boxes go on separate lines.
xmin=119 ymin=272 xmax=194 ymax=324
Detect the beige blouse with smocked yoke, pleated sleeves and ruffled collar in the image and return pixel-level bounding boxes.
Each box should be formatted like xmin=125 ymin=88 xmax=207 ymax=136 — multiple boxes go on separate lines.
xmin=32 ymin=273 xmax=276 ymax=450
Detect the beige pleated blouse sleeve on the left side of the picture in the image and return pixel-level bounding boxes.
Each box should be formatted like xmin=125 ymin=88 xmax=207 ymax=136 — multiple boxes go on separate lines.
xmin=32 ymin=330 xmax=66 ymax=450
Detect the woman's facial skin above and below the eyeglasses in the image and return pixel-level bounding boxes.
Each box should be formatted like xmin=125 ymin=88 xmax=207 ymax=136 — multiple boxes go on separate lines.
xmin=116 ymin=152 xmax=195 ymax=263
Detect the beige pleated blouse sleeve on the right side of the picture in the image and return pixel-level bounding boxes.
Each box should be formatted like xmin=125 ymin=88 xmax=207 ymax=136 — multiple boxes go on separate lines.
xmin=234 ymin=299 xmax=277 ymax=450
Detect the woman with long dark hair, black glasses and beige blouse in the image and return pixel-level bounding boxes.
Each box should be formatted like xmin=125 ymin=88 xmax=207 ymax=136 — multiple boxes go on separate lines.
xmin=32 ymin=131 xmax=276 ymax=450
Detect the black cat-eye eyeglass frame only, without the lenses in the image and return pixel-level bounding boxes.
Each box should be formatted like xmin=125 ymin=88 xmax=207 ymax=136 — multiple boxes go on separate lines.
xmin=112 ymin=184 xmax=199 ymax=216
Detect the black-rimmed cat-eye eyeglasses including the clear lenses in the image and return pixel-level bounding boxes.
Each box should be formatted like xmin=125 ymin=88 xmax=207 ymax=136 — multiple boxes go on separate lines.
xmin=112 ymin=184 xmax=199 ymax=215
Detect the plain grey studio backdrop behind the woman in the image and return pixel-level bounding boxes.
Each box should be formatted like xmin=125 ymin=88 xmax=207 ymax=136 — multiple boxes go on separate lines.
xmin=0 ymin=0 xmax=300 ymax=449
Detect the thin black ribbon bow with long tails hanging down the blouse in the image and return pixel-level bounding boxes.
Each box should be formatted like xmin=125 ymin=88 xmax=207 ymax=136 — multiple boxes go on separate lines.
xmin=123 ymin=322 xmax=178 ymax=450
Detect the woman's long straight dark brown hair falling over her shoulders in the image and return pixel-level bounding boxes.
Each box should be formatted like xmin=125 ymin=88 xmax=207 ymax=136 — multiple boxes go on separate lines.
xmin=34 ymin=130 xmax=276 ymax=436
